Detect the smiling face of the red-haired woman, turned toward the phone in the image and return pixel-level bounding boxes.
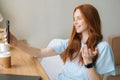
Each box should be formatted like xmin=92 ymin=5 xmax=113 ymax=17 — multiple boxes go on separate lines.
xmin=73 ymin=9 xmax=87 ymax=33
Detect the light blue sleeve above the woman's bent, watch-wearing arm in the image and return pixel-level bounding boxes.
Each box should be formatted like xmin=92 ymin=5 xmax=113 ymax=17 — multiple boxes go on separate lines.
xmin=95 ymin=41 xmax=115 ymax=75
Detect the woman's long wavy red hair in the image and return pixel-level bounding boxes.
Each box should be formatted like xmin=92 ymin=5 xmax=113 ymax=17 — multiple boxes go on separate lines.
xmin=61 ymin=4 xmax=103 ymax=63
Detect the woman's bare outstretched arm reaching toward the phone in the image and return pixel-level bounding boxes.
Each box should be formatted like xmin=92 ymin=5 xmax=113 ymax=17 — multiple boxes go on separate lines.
xmin=10 ymin=34 xmax=57 ymax=57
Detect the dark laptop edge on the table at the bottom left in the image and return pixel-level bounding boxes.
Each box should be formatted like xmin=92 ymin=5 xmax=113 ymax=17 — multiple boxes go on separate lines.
xmin=0 ymin=74 xmax=42 ymax=80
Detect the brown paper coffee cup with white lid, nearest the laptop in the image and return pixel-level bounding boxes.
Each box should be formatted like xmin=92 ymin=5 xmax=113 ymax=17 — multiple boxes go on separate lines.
xmin=0 ymin=52 xmax=11 ymax=68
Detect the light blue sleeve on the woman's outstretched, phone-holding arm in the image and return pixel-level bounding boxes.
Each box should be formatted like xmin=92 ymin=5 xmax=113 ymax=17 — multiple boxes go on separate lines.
xmin=48 ymin=39 xmax=68 ymax=54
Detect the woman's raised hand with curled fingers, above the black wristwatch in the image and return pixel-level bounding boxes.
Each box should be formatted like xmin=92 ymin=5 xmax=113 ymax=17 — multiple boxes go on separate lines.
xmin=82 ymin=45 xmax=98 ymax=65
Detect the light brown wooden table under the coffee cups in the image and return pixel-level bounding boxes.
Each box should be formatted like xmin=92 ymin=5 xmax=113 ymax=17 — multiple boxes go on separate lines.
xmin=0 ymin=46 xmax=49 ymax=80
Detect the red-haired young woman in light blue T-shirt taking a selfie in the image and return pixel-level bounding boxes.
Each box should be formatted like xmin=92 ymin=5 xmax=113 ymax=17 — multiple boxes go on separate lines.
xmin=10 ymin=4 xmax=115 ymax=80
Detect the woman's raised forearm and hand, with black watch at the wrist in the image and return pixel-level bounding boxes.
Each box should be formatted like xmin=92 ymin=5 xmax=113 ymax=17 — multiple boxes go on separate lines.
xmin=82 ymin=45 xmax=103 ymax=80
